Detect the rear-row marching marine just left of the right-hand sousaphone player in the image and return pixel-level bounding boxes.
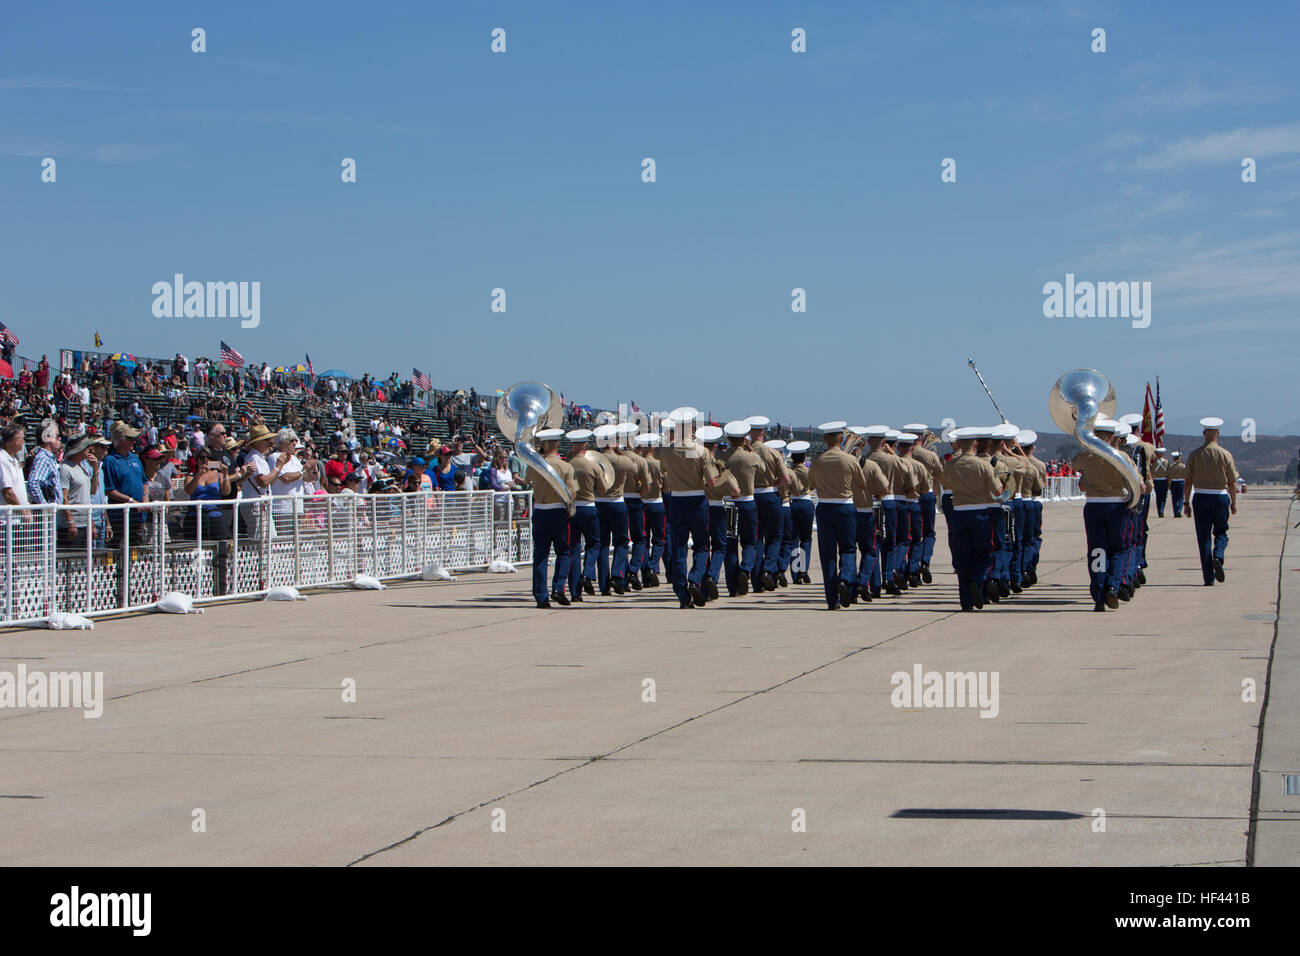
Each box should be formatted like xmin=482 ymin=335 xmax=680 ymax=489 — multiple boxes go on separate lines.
xmin=944 ymin=427 xmax=1006 ymax=611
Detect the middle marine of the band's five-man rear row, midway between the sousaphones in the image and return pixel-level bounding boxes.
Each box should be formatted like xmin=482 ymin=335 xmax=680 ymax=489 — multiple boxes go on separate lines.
xmin=809 ymin=421 xmax=865 ymax=610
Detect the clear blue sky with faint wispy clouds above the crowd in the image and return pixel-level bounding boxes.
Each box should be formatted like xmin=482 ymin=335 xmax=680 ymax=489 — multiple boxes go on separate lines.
xmin=0 ymin=1 xmax=1300 ymax=433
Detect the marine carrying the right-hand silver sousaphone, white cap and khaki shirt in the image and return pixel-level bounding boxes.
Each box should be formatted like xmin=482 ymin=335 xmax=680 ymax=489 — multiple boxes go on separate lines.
xmin=1071 ymin=419 xmax=1128 ymax=611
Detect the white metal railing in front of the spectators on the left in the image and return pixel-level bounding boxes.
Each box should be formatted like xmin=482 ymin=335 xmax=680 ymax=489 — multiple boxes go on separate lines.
xmin=0 ymin=492 xmax=533 ymax=627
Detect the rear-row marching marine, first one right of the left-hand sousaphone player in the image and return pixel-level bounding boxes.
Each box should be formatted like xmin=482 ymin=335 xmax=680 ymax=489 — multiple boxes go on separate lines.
xmin=659 ymin=407 xmax=718 ymax=609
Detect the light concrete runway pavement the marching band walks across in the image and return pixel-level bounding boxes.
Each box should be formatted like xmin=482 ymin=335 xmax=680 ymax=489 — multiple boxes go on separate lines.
xmin=0 ymin=493 xmax=1300 ymax=866
